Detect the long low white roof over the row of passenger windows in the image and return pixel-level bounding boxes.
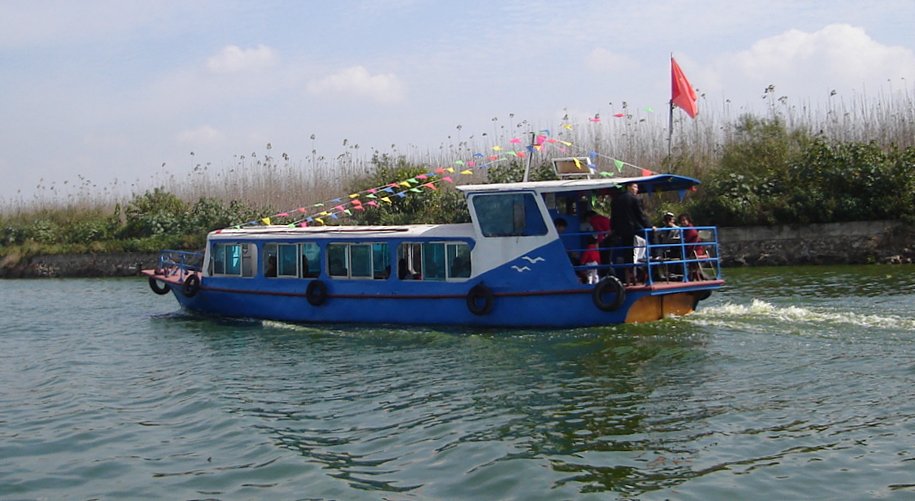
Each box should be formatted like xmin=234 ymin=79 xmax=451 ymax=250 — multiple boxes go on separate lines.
xmin=210 ymin=223 xmax=473 ymax=239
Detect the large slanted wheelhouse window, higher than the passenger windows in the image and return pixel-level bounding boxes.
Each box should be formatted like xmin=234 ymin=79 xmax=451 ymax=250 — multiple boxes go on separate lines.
xmin=473 ymin=193 xmax=547 ymax=237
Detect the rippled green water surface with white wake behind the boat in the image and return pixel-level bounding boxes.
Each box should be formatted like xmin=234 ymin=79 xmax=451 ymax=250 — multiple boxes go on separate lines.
xmin=0 ymin=266 xmax=915 ymax=500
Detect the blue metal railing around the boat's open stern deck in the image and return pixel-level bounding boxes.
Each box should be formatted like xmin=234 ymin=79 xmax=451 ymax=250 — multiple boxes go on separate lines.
xmin=563 ymin=226 xmax=721 ymax=285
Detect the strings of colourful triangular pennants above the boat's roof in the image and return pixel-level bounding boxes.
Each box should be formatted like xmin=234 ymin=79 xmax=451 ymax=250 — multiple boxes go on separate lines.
xmin=231 ymin=123 xmax=655 ymax=229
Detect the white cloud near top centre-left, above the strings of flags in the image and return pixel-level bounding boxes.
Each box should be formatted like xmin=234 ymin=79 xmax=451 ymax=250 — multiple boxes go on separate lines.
xmin=305 ymin=66 xmax=405 ymax=104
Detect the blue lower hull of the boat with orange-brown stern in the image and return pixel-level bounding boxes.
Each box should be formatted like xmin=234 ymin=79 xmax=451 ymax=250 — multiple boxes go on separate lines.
xmin=144 ymin=270 xmax=722 ymax=328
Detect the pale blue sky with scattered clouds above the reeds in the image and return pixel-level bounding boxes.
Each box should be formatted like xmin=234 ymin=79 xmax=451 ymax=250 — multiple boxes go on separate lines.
xmin=0 ymin=0 xmax=915 ymax=202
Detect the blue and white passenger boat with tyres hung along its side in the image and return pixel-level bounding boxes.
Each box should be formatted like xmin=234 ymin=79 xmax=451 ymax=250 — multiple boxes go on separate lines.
xmin=142 ymin=166 xmax=724 ymax=328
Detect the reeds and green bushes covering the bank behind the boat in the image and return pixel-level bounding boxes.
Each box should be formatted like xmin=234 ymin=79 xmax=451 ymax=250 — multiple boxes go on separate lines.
xmin=0 ymin=86 xmax=915 ymax=269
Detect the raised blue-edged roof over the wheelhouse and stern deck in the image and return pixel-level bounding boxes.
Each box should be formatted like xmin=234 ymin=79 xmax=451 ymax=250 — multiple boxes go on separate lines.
xmin=457 ymin=174 xmax=699 ymax=194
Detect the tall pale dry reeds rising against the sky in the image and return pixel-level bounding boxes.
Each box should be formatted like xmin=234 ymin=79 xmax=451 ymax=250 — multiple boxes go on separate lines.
xmin=0 ymin=86 xmax=915 ymax=217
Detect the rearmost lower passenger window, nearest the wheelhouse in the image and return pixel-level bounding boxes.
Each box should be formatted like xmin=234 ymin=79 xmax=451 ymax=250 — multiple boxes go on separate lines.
xmin=397 ymin=242 xmax=470 ymax=281
